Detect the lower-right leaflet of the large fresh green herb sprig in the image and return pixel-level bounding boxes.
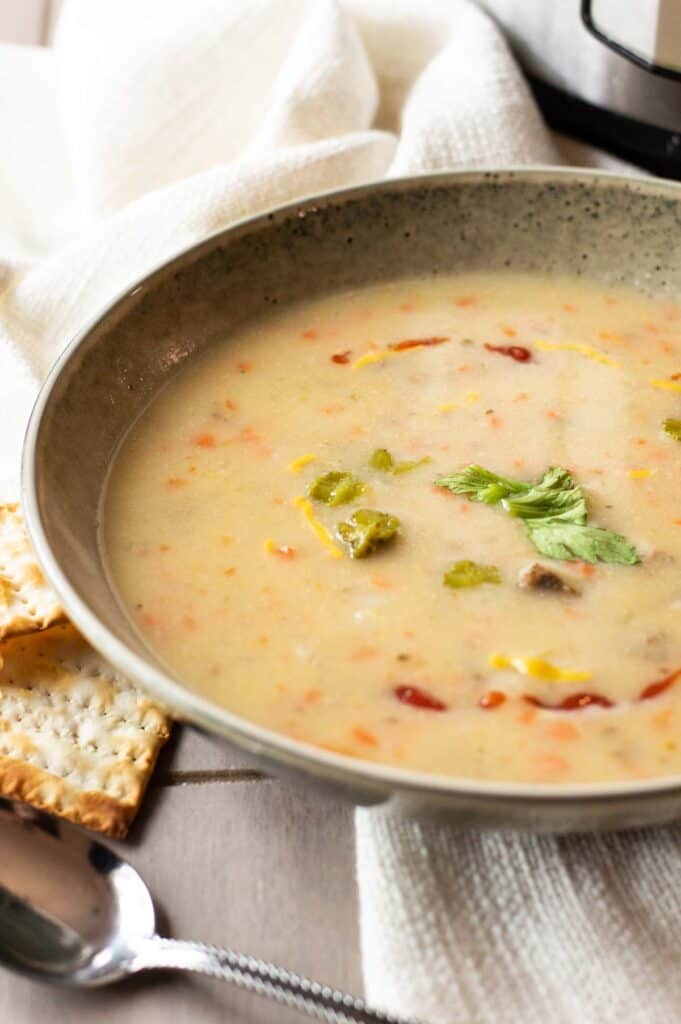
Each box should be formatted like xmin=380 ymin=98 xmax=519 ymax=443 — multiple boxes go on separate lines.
xmin=525 ymin=519 xmax=639 ymax=565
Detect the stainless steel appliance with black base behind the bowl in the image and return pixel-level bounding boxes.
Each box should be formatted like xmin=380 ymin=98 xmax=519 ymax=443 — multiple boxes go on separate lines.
xmin=479 ymin=0 xmax=681 ymax=180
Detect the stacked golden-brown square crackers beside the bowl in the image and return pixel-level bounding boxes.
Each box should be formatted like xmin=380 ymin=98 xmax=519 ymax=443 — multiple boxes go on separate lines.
xmin=0 ymin=505 xmax=170 ymax=838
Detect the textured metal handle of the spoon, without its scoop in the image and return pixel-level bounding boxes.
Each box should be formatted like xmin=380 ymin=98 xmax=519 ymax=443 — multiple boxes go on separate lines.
xmin=130 ymin=935 xmax=418 ymax=1024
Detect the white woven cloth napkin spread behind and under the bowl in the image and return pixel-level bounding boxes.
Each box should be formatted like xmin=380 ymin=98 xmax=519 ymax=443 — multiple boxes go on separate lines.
xmin=0 ymin=0 xmax=659 ymax=1024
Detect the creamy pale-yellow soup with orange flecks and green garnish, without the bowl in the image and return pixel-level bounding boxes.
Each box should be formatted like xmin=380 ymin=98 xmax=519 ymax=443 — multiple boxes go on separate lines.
xmin=102 ymin=273 xmax=681 ymax=783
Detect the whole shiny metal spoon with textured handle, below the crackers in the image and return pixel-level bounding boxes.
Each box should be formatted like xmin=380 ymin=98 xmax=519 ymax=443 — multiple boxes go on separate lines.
xmin=0 ymin=799 xmax=416 ymax=1024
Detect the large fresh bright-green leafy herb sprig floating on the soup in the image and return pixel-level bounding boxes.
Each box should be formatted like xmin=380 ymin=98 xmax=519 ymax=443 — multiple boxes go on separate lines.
xmin=435 ymin=466 xmax=639 ymax=565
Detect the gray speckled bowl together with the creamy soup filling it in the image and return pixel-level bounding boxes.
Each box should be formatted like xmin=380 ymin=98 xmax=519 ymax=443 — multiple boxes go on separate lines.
xmin=19 ymin=168 xmax=681 ymax=830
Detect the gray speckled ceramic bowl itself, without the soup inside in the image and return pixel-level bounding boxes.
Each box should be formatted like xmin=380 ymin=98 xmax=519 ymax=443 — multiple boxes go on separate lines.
xmin=18 ymin=168 xmax=681 ymax=831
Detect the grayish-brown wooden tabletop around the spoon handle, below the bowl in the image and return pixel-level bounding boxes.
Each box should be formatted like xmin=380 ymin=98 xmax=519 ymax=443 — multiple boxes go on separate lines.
xmin=0 ymin=728 xmax=361 ymax=1024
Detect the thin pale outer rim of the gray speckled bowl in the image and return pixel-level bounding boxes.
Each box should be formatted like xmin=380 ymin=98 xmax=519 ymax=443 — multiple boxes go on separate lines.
xmin=22 ymin=164 xmax=681 ymax=809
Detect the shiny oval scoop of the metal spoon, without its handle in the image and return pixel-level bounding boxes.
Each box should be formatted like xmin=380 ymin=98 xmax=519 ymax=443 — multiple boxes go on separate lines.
xmin=0 ymin=800 xmax=156 ymax=986
